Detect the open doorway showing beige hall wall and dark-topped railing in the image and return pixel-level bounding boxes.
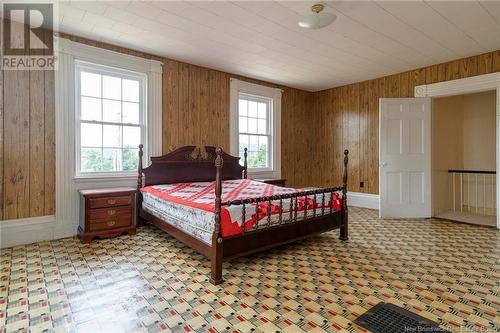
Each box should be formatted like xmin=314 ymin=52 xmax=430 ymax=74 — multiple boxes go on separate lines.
xmin=432 ymin=90 xmax=497 ymax=227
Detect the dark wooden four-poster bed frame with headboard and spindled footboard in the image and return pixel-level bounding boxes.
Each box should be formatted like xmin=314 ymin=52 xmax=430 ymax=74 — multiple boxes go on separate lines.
xmin=137 ymin=145 xmax=349 ymax=284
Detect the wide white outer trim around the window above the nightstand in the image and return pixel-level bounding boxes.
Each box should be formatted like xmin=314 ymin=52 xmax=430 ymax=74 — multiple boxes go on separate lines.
xmin=53 ymin=37 xmax=163 ymax=239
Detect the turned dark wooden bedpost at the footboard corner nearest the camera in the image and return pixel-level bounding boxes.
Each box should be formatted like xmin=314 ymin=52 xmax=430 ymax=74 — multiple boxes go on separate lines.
xmin=210 ymin=147 xmax=224 ymax=284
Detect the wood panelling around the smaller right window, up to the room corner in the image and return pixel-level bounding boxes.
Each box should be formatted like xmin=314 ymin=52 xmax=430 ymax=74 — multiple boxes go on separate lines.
xmin=163 ymin=60 xmax=313 ymax=186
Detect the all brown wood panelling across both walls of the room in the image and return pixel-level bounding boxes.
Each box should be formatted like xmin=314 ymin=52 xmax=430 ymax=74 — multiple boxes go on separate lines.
xmin=0 ymin=28 xmax=500 ymax=220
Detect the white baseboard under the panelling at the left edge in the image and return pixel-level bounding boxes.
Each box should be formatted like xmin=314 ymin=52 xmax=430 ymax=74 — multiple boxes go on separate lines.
xmin=0 ymin=215 xmax=61 ymax=248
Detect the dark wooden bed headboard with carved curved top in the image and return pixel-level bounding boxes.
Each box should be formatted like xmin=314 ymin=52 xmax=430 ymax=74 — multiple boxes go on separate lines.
xmin=137 ymin=145 xmax=246 ymax=188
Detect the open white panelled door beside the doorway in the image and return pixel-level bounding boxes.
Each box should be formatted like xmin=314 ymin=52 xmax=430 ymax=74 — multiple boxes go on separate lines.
xmin=379 ymin=98 xmax=431 ymax=218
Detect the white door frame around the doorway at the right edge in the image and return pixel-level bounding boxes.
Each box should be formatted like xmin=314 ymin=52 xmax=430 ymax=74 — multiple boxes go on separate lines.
xmin=415 ymin=73 xmax=500 ymax=229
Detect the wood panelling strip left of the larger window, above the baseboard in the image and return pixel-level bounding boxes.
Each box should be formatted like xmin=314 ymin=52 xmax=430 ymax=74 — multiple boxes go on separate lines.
xmin=0 ymin=66 xmax=55 ymax=220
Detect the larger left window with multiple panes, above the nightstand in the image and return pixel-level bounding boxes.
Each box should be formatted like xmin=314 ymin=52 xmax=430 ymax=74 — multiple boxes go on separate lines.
xmin=75 ymin=61 xmax=147 ymax=176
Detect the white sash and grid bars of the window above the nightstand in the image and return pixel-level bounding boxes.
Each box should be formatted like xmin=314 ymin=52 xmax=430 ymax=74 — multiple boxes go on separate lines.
xmin=75 ymin=60 xmax=147 ymax=178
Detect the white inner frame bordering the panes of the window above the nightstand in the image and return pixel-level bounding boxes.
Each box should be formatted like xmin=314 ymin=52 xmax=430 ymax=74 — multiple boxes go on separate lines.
xmin=75 ymin=60 xmax=148 ymax=178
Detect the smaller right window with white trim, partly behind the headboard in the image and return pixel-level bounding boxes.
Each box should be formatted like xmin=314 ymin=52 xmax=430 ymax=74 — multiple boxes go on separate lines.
xmin=231 ymin=79 xmax=281 ymax=178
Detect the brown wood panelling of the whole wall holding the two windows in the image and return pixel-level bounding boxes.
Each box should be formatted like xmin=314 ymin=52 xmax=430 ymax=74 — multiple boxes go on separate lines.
xmin=0 ymin=33 xmax=313 ymax=220
